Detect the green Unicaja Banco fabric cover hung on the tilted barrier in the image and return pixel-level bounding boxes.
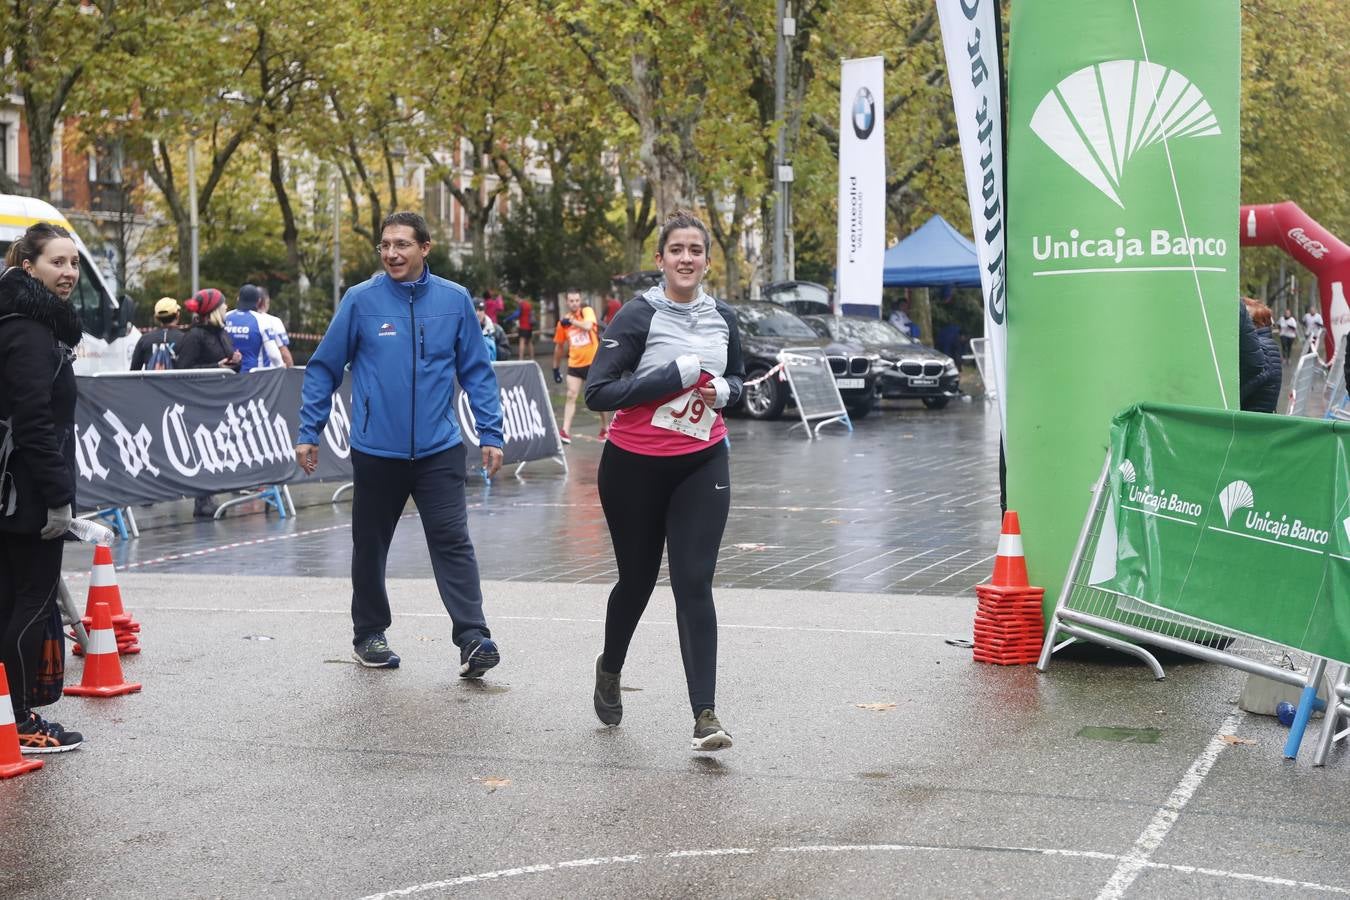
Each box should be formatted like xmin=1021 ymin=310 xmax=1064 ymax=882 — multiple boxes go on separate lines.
xmin=1092 ymin=403 xmax=1350 ymax=663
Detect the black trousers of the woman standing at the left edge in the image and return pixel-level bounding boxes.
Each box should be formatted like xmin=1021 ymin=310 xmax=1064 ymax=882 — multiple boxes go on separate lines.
xmin=0 ymin=532 xmax=63 ymax=722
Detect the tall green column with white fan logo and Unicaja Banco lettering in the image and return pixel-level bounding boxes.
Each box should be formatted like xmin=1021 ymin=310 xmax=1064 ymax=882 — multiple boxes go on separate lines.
xmin=1004 ymin=0 xmax=1239 ymax=610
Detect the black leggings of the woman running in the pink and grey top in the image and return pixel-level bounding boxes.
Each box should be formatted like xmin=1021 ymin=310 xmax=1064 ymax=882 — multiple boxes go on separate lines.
xmin=597 ymin=441 xmax=732 ymax=716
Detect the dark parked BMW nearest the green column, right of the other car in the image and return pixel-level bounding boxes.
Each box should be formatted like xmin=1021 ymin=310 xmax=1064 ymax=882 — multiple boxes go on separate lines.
xmin=802 ymin=316 xmax=961 ymax=409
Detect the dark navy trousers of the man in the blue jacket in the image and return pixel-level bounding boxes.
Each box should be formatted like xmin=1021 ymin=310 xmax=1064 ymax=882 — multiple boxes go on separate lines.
xmin=351 ymin=444 xmax=491 ymax=646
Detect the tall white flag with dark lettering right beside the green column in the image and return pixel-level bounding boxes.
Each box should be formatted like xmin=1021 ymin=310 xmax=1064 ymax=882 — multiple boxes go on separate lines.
xmin=937 ymin=0 xmax=1008 ymax=429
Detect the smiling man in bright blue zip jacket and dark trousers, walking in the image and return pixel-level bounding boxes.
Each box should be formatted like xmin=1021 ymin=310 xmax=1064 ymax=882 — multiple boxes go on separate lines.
xmin=296 ymin=212 xmax=502 ymax=679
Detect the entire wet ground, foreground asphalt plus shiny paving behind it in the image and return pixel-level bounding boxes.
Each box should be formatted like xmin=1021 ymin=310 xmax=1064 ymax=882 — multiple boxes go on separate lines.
xmin=13 ymin=391 xmax=1350 ymax=900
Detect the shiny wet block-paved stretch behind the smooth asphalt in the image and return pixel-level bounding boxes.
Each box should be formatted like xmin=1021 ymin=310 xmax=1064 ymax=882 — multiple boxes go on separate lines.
xmin=68 ymin=402 xmax=999 ymax=595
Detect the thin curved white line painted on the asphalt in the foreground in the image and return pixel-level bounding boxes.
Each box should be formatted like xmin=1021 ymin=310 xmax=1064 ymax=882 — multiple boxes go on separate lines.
xmin=362 ymin=843 xmax=1350 ymax=900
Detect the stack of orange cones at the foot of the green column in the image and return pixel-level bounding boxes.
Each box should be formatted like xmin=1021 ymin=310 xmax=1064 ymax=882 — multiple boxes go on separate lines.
xmin=975 ymin=511 xmax=1045 ymax=665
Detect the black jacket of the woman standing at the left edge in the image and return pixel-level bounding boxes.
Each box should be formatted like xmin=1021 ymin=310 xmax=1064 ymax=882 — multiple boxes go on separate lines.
xmin=0 ymin=267 xmax=82 ymax=534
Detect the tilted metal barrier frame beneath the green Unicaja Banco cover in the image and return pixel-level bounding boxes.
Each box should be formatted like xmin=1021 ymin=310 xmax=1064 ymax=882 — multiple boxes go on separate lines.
xmin=1035 ymin=455 xmax=1332 ymax=758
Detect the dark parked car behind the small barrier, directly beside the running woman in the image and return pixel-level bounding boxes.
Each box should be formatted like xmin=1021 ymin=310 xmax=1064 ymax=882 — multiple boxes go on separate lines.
xmin=732 ymin=301 xmax=880 ymax=418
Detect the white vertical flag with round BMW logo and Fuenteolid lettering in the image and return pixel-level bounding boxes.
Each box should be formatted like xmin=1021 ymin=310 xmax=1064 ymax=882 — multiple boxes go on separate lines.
xmin=834 ymin=57 xmax=886 ymax=318
